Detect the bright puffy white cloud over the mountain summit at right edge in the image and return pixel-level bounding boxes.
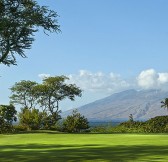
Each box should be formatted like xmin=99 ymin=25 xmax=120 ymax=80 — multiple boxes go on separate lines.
xmin=137 ymin=69 xmax=168 ymax=89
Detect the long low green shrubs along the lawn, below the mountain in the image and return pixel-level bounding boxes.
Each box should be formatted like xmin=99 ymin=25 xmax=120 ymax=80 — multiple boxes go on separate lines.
xmin=90 ymin=116 xmax=168 ymax=133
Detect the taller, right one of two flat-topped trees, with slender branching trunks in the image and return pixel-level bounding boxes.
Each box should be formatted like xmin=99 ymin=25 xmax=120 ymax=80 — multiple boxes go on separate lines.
xmin=35 ymin=76 xmax=82 ymax=118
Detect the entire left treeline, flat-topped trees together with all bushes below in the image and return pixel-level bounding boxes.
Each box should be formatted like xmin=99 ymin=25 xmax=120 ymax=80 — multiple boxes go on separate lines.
xmin=0 ymin=76 xmax=89 ymax=133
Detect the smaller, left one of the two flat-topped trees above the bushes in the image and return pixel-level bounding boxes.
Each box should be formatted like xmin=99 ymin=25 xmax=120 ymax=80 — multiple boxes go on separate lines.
xmin=10 ymin=80 xmax=37 ymax=109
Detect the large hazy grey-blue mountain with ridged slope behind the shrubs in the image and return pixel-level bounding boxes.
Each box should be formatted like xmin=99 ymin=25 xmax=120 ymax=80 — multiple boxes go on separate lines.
xmin=62 ymin=89 xmax=168 ymax=121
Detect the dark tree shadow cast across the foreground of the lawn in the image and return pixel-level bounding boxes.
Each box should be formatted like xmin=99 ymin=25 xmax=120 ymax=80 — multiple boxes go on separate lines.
xmin=0 ymin=144 xmax=168 ymax=162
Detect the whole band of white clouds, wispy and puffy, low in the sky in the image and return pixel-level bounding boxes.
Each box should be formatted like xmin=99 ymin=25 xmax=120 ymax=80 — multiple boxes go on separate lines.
xmin=38 ymin=69 xmax=168 ymax=95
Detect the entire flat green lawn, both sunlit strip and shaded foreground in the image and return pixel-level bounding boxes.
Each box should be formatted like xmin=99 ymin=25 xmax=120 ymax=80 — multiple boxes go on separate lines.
xmin=0 ymin=132 xmax=168 ymax=162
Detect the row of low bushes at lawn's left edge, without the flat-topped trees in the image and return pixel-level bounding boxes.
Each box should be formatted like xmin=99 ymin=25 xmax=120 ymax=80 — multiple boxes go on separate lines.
xmin=0 ymin=105 xmax=89 ymax=133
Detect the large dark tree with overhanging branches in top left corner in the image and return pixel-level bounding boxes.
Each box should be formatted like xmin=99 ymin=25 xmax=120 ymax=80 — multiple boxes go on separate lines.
xmin=0 ymin=0 xmax=60 ymax=66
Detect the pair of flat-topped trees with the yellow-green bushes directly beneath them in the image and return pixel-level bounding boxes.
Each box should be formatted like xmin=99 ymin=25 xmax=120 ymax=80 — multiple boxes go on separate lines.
xmin=10 ymin=76 xmax=82 ymax=130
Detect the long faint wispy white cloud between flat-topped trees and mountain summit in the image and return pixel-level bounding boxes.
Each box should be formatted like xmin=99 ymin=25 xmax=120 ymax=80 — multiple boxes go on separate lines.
xmin=68 ymin=70 xmax=130 ymax=94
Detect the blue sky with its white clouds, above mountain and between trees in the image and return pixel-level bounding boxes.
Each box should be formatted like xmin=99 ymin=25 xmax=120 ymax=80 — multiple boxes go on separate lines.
xmin=0 ymin=0 xmax=168 ymax=110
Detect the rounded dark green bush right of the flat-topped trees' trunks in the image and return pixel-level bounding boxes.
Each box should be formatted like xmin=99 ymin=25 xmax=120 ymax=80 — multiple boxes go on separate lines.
xmin=63 ymin=110 xmax=89 ymax=133
